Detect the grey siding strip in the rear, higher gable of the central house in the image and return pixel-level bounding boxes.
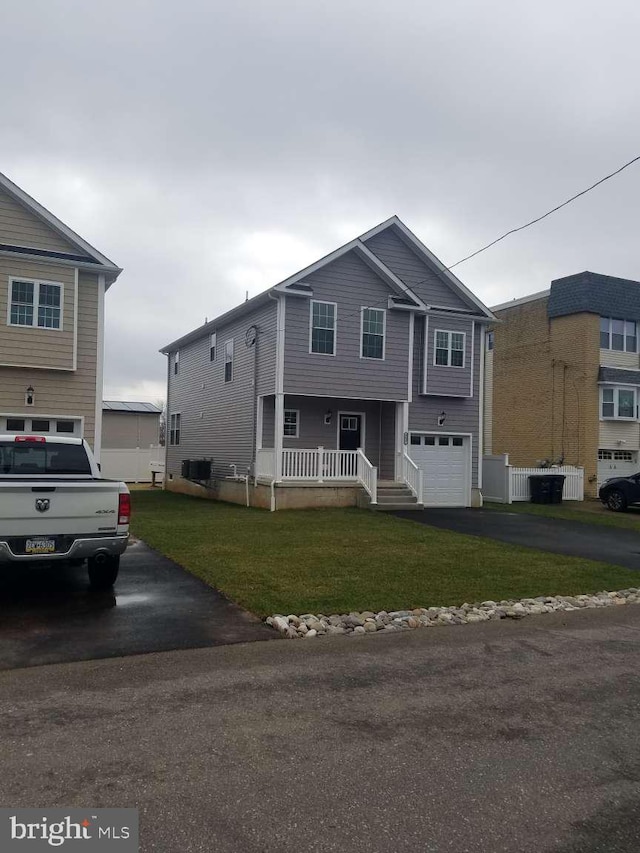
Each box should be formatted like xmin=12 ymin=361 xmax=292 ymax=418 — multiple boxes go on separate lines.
xmin=365 ymin=229 xmax=470 ymax=310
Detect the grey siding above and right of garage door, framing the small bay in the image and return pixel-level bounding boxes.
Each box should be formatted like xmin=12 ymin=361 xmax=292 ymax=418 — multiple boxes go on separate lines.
xmin=409 ymin=318 xmax=482 ymax=488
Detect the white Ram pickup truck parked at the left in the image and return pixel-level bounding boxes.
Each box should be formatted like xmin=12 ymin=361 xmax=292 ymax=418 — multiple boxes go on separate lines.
xmin=0 ymin=435 xmax=131 ymax=589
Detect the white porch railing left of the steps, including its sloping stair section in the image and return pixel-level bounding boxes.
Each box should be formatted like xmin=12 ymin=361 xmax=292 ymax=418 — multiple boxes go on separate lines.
xmin=256 ymin=447 xmax=378 ymax=503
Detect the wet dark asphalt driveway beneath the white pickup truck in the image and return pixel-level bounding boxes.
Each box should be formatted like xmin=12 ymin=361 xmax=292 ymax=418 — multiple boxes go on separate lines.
xmin=0 ymin=543 xmax=277 ymax=669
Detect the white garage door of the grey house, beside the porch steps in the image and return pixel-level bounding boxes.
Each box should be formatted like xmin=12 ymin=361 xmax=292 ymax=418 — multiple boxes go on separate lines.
xmin=409 ymin=432 xmax=471 ymax=506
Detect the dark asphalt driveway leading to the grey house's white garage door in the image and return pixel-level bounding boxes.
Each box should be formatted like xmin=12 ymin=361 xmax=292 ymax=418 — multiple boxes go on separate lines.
xmin=394 ymin=509 xmax=640 ymax=569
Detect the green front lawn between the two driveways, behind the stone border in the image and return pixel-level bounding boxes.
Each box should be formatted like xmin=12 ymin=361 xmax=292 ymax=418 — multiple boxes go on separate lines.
xmin=132 ymin=491 xmax=638 ymax=616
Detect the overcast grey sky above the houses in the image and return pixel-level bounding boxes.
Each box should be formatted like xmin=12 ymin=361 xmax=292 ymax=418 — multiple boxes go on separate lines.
xmin=0 ymin=0 xmax=640 ymax=400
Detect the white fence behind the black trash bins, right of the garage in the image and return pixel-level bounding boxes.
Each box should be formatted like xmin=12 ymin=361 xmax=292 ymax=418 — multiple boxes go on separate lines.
xmin=482 ymin=453 xmax=584 ymax=504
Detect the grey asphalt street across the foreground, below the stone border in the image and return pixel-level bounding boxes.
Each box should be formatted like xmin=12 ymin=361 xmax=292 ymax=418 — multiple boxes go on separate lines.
xmin=0 ymin=605 xmax=640 ymax=853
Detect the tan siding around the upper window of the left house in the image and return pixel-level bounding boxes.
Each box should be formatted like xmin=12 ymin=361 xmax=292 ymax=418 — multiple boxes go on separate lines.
xmin=0 ymin=257 xmax=75 ymax=370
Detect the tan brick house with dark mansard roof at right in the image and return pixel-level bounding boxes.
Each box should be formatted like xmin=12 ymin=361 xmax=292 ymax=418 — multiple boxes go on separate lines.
xmin=484 ymin=272 xmax=640 ymax=496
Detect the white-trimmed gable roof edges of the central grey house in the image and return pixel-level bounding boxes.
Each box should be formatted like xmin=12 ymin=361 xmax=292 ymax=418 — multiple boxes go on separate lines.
xmin=160 ymin=220 xmax=496 ymax=354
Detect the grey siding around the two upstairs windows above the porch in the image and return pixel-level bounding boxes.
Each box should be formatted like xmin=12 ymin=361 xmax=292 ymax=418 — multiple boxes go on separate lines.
xmin=284 ymin=252 xmax=409 ymax=400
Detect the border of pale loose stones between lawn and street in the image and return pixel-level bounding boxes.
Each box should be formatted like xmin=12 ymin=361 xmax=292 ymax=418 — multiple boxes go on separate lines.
xmin=265 ymin=587 xmax=640 ymax=640
